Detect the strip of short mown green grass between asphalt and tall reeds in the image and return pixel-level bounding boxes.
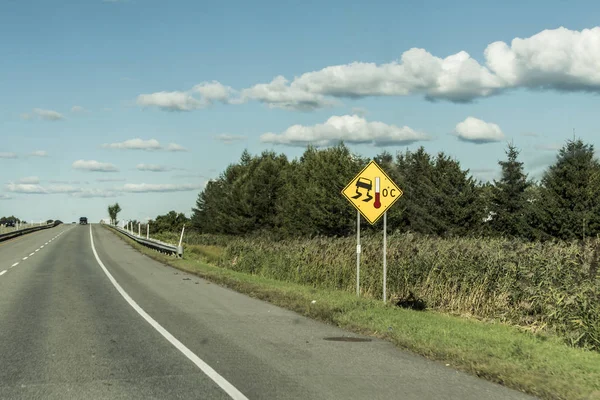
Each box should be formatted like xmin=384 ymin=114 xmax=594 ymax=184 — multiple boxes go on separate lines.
xmin=107 ymin=228 xmax=600 ymax=400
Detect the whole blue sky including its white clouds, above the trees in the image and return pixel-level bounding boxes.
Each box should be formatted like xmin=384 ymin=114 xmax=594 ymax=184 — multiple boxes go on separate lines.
xmin=0 ymin=0 xmax=600 ymax=221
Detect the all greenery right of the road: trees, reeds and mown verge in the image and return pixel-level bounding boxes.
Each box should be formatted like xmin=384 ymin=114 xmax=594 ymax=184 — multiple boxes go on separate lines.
xmin=110 ymin=139 xmax=600 ymax=398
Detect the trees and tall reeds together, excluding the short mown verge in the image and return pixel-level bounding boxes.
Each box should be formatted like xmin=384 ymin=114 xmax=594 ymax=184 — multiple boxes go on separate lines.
xmin=151 ymin=140 xmax=600 ymax=351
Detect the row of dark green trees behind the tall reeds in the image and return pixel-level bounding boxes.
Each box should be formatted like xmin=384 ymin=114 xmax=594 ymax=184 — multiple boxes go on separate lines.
xmin=191 ymin=139 xmax=600 ymax=240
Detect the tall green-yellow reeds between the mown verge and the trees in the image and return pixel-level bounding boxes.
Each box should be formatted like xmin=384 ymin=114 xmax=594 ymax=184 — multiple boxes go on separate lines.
xmin=185 ymin=233 xmax=600 ymax=350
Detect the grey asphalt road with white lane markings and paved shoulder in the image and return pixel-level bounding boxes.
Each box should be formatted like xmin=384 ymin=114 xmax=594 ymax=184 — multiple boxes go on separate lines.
xmin=0 ymin=225 xmax=530 ymax=400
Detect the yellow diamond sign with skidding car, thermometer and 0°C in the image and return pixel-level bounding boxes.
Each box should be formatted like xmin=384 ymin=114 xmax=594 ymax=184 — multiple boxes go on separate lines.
xmin=342 ymin=161 xmax=402 ymax=225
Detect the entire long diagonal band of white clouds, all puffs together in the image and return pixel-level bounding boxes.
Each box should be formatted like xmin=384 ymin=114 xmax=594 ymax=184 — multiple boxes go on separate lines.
xmin=144 ymin=27 xmax=600 ymax=111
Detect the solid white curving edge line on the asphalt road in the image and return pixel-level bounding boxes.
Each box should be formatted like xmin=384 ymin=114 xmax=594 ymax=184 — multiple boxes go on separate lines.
xmin=90 ymin=225 xmax=248 ymax=400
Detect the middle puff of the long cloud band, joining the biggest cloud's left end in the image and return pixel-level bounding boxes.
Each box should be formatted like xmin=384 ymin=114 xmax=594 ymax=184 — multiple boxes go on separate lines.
xmin=241 ymin=76 xmax=338 ymax=111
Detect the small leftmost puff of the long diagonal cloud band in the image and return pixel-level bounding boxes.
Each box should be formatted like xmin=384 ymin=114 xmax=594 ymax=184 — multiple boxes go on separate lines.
xmin=137 ymin=81 xmax=241 ymax=111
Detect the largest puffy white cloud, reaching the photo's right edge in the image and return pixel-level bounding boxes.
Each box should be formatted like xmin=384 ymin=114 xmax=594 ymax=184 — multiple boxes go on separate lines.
xmin=289 ymin=27 xmax=600 ymax=102
